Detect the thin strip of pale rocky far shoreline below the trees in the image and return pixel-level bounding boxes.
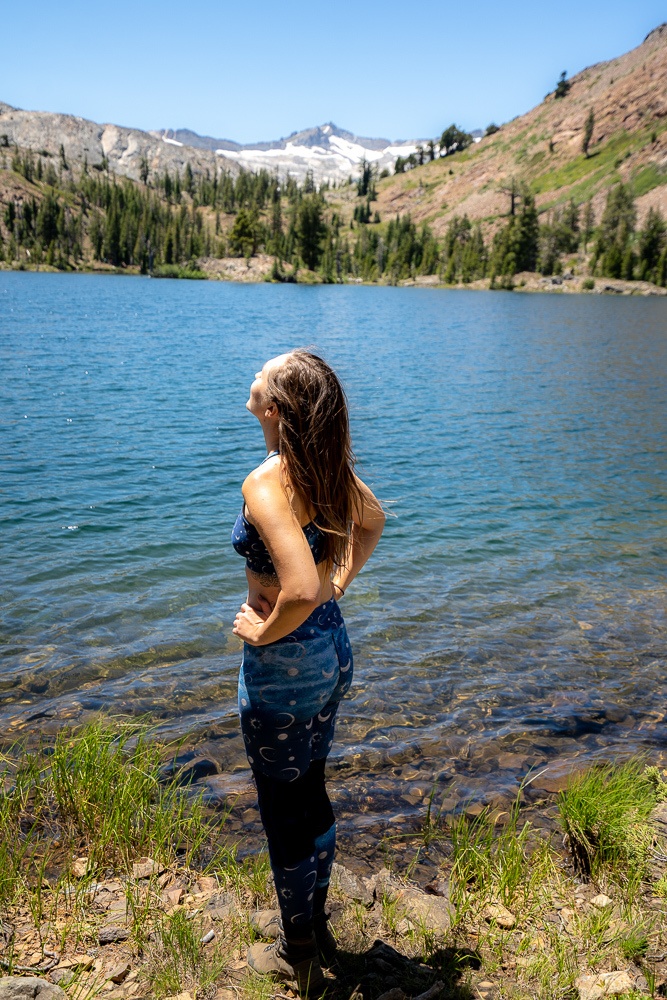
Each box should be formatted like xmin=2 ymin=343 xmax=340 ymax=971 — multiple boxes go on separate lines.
xmin=0 ymin=255 xmax=667 ymax=297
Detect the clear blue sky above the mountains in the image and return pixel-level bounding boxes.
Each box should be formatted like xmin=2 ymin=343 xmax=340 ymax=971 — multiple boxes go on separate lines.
xmin=0 ymin=0 xmax=667 ymax=142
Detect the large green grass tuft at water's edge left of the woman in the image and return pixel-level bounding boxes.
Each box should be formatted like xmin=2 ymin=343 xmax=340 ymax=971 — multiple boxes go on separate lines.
xmin=0 ymin=721 xmax=211 ymax=911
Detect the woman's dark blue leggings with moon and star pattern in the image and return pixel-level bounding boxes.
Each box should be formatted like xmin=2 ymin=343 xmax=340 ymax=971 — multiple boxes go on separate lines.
xmin=239 ymin=599 xmax=353 ymax=937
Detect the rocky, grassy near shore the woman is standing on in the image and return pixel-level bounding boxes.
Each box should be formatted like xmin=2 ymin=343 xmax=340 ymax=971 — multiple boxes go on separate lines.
xmin=0 ymin=723 xmax=667 ymax=1000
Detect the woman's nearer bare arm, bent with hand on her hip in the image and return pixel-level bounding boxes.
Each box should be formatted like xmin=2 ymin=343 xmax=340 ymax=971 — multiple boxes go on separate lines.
xmin=233 ymin=462 xmax=320 ymax=646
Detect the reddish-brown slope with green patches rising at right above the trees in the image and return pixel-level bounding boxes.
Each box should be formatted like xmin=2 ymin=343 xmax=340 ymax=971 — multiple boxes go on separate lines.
xmin=378 ymin=24 xmax=667 ymax=234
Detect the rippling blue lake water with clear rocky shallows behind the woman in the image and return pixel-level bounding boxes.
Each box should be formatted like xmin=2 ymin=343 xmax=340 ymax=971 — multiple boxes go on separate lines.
xmin=0 ymin=273 xmax=667 ymax=840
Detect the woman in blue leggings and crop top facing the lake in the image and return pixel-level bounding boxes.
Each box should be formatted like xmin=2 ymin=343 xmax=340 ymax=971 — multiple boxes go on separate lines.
xmin=232 ymin=350 xmax=385 ymax=996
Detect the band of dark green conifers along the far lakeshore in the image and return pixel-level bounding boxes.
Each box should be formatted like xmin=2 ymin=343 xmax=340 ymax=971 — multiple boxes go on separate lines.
xmin=0 ymin=145 xmax=667 ymax=287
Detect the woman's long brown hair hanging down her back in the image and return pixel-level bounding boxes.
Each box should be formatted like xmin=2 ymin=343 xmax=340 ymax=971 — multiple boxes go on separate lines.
xmin=267 ymin=348 xmax=363 ymax=566
